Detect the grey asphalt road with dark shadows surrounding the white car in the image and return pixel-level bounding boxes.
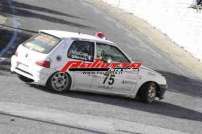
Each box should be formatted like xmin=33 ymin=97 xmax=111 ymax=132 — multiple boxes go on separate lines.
xmin=0 ymin=0 xmax=202 ymax=134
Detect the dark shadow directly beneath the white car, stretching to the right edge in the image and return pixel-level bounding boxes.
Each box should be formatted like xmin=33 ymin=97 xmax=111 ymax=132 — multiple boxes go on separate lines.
xmin=32 ymin=85 xmax=202 ymax=122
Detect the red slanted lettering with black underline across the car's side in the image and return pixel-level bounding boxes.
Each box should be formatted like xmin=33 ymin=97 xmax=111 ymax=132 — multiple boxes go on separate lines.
xmin=60 ymin=59 xmax=142 ymax=72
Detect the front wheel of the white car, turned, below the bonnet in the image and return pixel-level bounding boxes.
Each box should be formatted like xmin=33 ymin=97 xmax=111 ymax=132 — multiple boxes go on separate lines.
xmin=138 ymin=82 xmax=157 ymax=103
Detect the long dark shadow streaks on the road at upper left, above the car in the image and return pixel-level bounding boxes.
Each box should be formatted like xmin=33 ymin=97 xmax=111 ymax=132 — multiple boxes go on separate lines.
xmin=0 ymin=1 xmax=92 ymax=29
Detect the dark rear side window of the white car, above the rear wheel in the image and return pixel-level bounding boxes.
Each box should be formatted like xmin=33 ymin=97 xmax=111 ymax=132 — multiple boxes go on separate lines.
xmin=67 ymin=41 xmax=94 ymax=61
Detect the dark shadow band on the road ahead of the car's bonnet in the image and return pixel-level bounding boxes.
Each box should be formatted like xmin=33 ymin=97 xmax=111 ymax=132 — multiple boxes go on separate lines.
xmin=158 ymin=71 xmax=202 ymax=97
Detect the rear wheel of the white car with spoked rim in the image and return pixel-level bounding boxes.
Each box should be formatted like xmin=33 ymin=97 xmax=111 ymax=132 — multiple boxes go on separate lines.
xmin=47 ymin=72 xmax=71 ymax=93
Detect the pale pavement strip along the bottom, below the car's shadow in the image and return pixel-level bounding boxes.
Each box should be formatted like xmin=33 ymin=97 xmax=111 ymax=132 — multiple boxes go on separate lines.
xmin=0 ymin=102 xmax=185 ymax=134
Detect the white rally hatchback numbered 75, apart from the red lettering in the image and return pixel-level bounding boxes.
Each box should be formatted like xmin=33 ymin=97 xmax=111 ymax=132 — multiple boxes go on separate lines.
xmin=11 ymin=30 xmax=167 ymax=103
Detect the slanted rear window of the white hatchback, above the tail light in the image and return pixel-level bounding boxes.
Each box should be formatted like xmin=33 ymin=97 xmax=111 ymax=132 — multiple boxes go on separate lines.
xmin=24 ymin=33 xmax=60 ymax=54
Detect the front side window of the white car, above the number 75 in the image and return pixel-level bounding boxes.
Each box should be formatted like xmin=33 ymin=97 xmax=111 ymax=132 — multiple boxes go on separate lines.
xmin=96 ymin=43 xmax=130 ymax=62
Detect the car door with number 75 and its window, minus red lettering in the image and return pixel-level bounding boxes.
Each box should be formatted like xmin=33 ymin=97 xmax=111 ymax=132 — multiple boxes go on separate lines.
xmin=92 ymin=43 xmax=138 ymax=94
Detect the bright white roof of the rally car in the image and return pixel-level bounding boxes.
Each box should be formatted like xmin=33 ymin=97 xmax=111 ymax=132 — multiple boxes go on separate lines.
xmin=39 ymin=30 xmax=115 ymax=45
